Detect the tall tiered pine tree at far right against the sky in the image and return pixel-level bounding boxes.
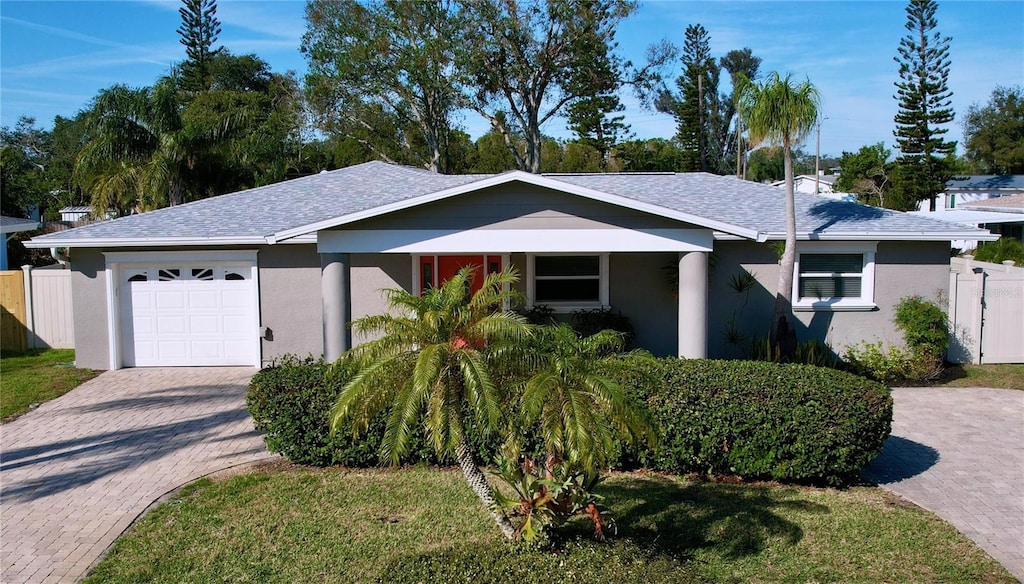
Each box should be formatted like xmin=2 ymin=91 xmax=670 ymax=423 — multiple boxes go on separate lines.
xmin=894 ymin=0 xmax=956 ymax=211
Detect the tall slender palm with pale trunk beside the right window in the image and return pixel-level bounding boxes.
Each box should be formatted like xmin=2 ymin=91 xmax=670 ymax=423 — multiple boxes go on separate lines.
xmin=739 ymin=73 xmax=820 ymax=357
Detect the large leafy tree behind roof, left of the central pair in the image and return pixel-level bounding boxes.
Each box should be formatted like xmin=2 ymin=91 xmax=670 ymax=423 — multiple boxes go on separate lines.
xmin=302 ymin=0 xmax=465 ymax=172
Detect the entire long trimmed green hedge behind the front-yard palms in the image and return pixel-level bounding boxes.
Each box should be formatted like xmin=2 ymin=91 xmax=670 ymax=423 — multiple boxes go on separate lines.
xmin=247 ymin=356 xmax=892 ymax=485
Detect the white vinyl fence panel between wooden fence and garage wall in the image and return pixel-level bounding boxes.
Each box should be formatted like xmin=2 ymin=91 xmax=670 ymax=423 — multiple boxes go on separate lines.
xmin=22 ymin=264 xmax=75 ymax=348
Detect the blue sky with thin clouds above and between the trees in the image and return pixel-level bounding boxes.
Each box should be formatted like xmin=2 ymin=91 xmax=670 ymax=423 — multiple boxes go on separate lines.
xmin=0 ymin=0 xmax=1024 ymax=155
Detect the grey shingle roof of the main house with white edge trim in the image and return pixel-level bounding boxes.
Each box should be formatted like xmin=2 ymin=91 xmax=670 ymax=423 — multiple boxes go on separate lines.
xmin=30 ymin=162 xmax=988 ymax=247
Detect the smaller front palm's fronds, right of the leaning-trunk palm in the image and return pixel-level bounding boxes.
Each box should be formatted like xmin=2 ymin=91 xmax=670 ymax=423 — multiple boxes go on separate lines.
xmin=515 ymin=324 xmax=656 ymax=475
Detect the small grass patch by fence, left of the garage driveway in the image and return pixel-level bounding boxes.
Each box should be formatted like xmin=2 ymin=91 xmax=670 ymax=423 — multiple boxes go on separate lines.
xmin=0 ymin=349 xmax=100 ymax=422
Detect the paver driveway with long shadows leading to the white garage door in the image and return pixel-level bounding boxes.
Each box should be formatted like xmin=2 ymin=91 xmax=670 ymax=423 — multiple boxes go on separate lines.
xmin=0 ymin=368 xmax=269 ymax=584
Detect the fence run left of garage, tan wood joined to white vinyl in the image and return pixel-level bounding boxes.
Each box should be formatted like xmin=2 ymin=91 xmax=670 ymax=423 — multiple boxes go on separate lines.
xmin=0 ymin=265 xmax=75 ymax=350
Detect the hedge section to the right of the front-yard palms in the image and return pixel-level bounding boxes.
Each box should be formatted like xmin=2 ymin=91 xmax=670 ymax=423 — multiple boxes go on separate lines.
xmin=617 ymin=357 xmax=892 ymax=485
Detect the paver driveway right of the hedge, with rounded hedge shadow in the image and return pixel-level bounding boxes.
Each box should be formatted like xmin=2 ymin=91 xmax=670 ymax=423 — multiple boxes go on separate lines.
xmin=863 ymin=387 xmax=1024 ymax=581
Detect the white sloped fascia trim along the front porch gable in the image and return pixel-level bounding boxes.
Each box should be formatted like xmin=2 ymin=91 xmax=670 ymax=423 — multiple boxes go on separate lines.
xmin=267 ymin=170 xmax=759 ymax=243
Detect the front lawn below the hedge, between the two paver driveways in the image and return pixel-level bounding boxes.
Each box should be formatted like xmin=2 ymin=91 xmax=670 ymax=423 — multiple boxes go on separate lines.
xmin=86 ymin=463 xmax=1015 ymax=584
